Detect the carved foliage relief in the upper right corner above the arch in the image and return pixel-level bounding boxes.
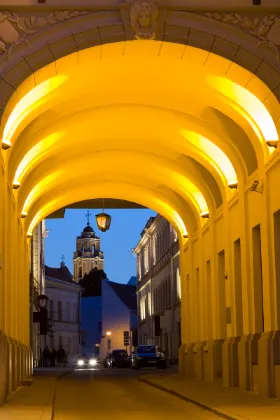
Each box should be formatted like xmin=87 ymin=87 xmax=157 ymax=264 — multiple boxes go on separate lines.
xmin=205 ymin=13 xmax=280 ymax=61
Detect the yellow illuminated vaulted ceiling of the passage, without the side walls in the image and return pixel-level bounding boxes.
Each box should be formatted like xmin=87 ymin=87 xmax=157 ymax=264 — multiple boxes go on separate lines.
xmin=1 ymin=41 xmax=278 ymax=242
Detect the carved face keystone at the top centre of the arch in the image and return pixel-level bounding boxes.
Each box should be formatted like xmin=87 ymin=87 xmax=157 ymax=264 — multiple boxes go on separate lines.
xmin=130 ymin=0 xmax=158 ymax=39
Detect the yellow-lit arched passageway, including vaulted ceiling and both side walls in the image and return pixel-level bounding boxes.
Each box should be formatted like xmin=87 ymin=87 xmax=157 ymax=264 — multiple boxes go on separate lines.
xmin=0 ymin=41 xmax=280 ymax=395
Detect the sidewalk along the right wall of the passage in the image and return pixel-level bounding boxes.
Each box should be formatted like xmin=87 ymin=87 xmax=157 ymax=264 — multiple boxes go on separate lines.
xmin=140 ymin=372 xmax=280 ymax=420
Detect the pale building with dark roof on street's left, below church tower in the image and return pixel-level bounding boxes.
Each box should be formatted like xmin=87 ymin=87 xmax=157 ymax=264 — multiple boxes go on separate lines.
xmin=44 ymin=262 xmax=81 ymax=363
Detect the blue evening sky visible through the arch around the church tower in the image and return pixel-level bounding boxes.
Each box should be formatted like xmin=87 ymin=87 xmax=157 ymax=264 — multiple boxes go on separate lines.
xmin=45 ymin=209 xmax=156 ymax=283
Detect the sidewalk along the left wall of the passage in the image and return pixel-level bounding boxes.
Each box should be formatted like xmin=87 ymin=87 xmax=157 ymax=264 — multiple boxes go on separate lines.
xmin=0 ymin=368 xmax=72 ymax=420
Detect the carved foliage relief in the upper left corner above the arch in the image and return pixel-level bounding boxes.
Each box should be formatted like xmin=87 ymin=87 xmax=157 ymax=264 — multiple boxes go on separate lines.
xmin=0 ymin=10 xmax=89 ymax=56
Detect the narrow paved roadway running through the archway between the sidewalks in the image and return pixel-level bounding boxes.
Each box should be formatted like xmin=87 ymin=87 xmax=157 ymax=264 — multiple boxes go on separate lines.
xmin=54 ymin=368 xmax=218 ymax=420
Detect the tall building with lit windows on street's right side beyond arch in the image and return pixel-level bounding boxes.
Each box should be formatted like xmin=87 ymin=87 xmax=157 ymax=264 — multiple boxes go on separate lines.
xmin=134 ymin=215 xmax=181 ymax=363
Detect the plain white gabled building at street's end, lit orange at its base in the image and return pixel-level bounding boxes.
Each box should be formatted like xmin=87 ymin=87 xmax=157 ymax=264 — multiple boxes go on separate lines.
xmin=100 ymin=280 xmax=137 ymax=360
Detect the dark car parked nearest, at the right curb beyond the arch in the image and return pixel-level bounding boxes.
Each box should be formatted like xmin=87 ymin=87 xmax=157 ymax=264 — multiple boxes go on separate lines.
xmin=131 ymin=345 xmax=167 ymax=369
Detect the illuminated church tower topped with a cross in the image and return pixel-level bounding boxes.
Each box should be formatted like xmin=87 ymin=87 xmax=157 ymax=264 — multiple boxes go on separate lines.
xmin=73 ymin=212 xmax=104 ymax=283
